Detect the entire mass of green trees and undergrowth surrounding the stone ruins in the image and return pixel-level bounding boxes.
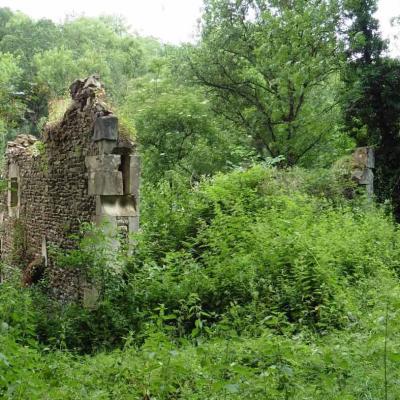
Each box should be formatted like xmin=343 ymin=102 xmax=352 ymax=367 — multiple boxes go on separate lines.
xmin=0 ymin=0 xmax=400 ymax=400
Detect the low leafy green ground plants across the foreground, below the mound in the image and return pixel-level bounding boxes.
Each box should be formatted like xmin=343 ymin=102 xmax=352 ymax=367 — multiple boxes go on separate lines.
xmin=0 ymin=274 xmax=400 ymax=400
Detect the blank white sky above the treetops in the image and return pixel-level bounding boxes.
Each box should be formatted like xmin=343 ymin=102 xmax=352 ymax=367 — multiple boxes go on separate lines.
xmin=0 ymin=0 xmax=400 ymax=55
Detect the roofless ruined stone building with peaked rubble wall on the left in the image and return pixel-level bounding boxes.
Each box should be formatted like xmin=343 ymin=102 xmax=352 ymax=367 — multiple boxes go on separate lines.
xmin=0 ymin=76 xmax=139 ymax=294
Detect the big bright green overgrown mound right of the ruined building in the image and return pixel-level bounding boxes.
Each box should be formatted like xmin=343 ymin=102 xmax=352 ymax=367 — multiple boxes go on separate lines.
xmin=129 ymin=167 xmax=397 ymax=330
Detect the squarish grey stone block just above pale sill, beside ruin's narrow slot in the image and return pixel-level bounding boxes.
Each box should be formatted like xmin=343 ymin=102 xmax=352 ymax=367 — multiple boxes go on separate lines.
xmin=88 ymin=171 xmax=124 ymax=196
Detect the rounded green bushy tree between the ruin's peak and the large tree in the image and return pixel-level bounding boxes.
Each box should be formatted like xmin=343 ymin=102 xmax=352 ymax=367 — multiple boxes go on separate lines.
xmin=135 ymin=89 xmax=245 ymax=181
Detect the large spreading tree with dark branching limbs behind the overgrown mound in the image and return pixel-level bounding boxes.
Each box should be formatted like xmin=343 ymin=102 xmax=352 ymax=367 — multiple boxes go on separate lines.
xmin=189 ymin=0 xmax=339 ymax=165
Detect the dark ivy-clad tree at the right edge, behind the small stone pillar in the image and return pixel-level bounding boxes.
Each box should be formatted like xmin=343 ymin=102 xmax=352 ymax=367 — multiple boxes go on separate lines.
xmin=343 ymin=0 xmax=400 ymax=218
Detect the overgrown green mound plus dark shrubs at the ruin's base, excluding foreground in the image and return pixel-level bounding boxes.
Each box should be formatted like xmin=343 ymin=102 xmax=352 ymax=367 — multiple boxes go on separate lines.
xmin=28 ymin=165 xmax=400 ymax=352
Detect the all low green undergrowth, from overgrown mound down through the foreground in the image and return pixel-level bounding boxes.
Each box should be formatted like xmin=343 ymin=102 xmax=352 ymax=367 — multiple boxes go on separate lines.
xmin=0 ymin=165 xmax=400 ymax=399
